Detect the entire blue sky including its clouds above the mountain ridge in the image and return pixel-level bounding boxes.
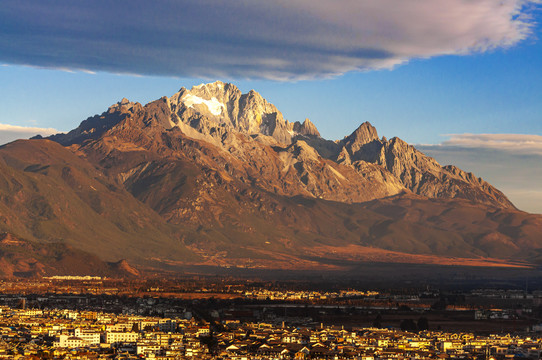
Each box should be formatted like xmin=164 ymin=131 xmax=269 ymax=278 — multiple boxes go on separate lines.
xmin=0 ymin=0 xmax=542 ymax=213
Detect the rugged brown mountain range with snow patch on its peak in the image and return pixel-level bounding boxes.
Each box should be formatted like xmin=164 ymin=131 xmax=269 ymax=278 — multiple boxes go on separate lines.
xmin=0 ymin=81 xmax=542 ymax=275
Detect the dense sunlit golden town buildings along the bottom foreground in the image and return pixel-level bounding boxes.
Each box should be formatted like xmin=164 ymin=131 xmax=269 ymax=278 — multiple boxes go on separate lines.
xmin=0 ymin=306 xmax=542 ymax=360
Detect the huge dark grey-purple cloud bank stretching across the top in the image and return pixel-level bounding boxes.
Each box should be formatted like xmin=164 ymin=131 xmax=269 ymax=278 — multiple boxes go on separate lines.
xmin=0 ymin=0 xmax=540 ymax=80
